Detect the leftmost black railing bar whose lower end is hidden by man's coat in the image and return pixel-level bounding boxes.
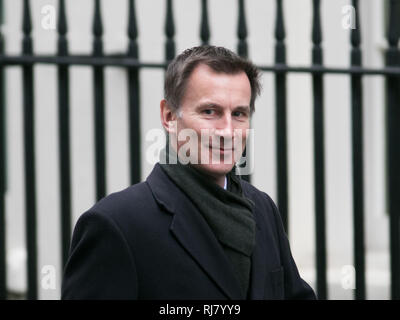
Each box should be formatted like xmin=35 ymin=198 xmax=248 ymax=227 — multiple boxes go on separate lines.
xmin=58 ymin=0 xmax=71 ymax=266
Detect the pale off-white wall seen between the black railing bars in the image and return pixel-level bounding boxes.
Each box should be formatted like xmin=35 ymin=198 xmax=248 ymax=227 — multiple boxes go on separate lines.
xmin=3 ymin=0 xmax=388 ymax=299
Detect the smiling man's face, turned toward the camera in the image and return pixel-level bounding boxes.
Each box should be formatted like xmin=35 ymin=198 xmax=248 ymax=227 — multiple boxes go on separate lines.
xmin=170 ymin=64 xmax=251 ymax=177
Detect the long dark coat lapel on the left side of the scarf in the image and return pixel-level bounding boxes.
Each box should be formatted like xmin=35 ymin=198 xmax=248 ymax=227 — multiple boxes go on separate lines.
xmin=147 ymin=164 xmax=243 ymax=299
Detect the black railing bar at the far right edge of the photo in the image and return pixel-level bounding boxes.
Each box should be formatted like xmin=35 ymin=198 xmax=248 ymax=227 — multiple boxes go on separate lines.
xmin=386 ymin=0 xmax=400 ymax=300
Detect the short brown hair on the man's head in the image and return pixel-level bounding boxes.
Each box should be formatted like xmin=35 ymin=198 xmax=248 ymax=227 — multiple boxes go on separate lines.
xmin=164 ymin=45 xmax=261 ymax=114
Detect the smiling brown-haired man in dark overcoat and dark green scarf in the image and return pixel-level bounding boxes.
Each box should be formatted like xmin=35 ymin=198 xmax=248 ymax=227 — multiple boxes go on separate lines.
xmin=62 ymin=46 xmax=315 ymax=299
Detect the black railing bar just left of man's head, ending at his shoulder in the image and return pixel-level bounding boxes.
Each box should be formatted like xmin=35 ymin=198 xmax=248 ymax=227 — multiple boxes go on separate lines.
xmin=128 ymin=0 xmax=141 ymax=184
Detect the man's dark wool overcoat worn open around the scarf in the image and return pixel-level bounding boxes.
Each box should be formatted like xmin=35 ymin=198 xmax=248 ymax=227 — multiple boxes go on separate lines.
xmin=61 ymin=164 xmax=315 ymax=300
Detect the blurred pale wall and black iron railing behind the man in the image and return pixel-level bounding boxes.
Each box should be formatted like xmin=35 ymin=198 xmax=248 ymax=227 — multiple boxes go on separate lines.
xmin=0 ymin=0 xmax=400 ymax=299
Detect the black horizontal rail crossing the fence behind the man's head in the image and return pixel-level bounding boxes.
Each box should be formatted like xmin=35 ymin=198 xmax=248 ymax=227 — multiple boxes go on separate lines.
xmin=0 ymin=55 xmax=400 ymax=76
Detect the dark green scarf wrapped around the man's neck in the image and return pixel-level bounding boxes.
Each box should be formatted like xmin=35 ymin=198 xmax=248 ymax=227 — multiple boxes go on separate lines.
xmin=160 ymin=142 xmax=255 ymax=299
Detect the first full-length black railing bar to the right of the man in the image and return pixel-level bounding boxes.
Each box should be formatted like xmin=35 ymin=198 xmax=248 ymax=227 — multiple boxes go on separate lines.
xmin=312 ymin=0 xmax=327 ymax=300
